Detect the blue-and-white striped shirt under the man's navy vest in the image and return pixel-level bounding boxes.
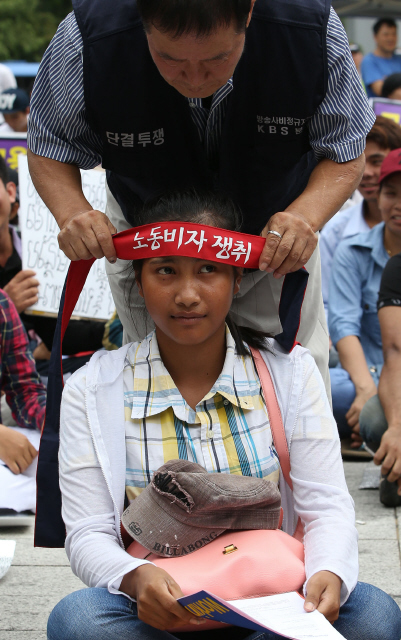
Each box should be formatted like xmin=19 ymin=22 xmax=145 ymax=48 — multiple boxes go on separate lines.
xmin=28 ymin=9 xmax=375 ymax=169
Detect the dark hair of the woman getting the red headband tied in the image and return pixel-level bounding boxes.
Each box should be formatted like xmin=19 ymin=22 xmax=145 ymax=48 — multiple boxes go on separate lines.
xmin=132 ymin=189 xmax=271 ymax=356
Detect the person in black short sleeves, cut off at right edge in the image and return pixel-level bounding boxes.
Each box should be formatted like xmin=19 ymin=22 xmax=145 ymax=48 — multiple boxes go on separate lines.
xmin=359 ymin=252 xmax=401 ymax=507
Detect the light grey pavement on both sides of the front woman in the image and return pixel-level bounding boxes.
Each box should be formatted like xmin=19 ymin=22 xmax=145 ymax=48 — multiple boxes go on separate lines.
xmin=0 ymin=461 xmax=401 ymax=640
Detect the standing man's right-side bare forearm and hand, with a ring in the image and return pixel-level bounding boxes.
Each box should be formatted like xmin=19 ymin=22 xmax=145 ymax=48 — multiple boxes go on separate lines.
xmin=259 ymin=154 xmax=365 ymax=277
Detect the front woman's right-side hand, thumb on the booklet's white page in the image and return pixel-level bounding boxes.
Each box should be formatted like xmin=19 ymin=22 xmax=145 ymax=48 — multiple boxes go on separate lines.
xmin=304 ymin=571 xmax=342 ymax=622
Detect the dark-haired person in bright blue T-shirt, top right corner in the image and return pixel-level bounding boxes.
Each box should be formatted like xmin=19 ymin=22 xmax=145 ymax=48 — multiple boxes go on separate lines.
xmin=361 ymin=18 xmax=401 ymax=98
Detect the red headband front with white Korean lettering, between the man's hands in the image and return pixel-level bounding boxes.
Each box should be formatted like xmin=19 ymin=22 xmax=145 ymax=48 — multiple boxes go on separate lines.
xmin=113 ymin=222 xmax=265 ymax=269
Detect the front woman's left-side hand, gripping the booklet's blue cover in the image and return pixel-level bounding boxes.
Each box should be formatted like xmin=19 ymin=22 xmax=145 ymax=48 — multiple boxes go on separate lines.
xmin=120 ymin=564 xmax=205 ymax=631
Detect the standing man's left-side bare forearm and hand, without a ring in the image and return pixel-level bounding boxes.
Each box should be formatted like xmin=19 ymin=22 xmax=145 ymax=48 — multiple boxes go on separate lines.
xmin=28 ymin=150 xmax=117 ymax=262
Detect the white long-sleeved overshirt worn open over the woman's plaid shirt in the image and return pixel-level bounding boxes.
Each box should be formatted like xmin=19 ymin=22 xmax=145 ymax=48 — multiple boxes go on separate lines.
xmin=59 ymin=340 xmax=358 ymax=604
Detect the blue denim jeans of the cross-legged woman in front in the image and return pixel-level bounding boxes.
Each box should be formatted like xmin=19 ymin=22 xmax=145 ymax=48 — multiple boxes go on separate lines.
xmin=47 ymin=582 xmax=401 ymax=640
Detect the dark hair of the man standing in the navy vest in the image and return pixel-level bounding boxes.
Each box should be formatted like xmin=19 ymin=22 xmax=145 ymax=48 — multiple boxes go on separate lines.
xmin=137 ymin=0 xmax=251 ymax=38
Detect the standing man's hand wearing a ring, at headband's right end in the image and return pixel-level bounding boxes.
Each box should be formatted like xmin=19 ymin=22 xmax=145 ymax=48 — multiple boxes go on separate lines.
xmin=259 ymin=211 xmax=317 ymax=278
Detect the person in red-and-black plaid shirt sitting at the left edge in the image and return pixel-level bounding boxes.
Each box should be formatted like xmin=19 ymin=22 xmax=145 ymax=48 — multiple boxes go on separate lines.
xmin=0 ymin=289 xmax=46 ymax=523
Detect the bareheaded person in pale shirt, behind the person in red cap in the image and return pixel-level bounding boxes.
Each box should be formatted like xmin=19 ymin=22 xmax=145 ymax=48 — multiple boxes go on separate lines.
xmin=320 ymin=116 xmax=401 ymax=315
